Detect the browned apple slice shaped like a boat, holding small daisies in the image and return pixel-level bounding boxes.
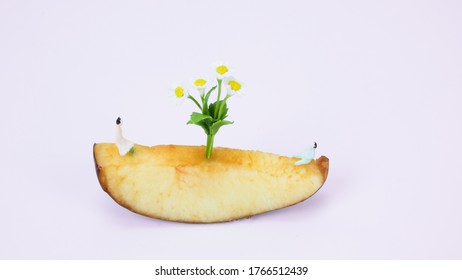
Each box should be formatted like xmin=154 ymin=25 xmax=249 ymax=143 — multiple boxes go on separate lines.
xmin=93 ymin=143 xmax=329 ymax=223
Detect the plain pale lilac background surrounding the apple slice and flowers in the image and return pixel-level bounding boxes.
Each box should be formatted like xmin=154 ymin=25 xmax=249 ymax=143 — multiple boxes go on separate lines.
xmin=0 ymin=1 xmax=462 ymax=259
